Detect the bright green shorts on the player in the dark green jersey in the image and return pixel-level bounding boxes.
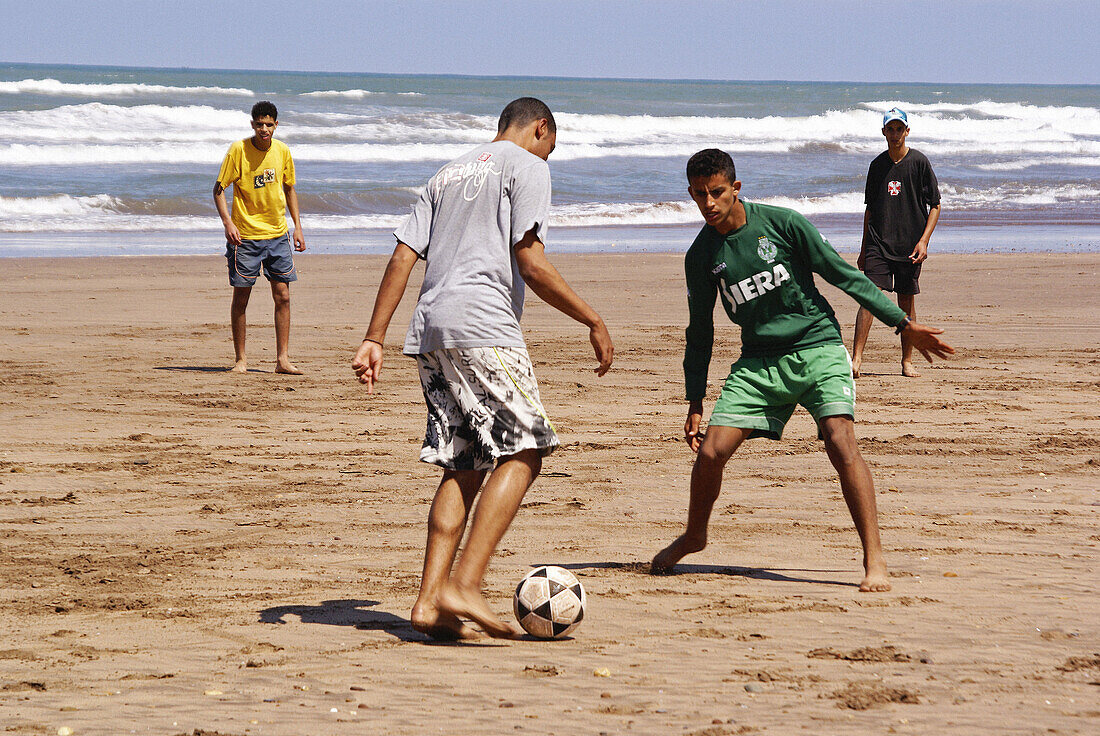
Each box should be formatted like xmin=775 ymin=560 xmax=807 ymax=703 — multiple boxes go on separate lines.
xmin=711 ymin=342 xmax=856 ymax=440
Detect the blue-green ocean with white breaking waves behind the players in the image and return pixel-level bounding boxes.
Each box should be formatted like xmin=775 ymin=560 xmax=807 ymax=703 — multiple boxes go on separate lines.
xmin=0 ymin=64 xmax=1100 ymax=256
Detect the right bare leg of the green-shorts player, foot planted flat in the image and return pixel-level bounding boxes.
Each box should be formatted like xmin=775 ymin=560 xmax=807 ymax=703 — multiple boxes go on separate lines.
xmin=821 ymin=417 xmax=890 ymax=593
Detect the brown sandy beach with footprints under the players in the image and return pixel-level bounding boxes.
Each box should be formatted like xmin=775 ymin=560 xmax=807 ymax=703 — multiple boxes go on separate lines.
xmin=0 ymin=249 xmax=1100 ymax=736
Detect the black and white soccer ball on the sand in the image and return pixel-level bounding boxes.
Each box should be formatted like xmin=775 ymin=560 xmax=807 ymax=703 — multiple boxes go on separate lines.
xmin=512 ymin=564 xmax=586 ymax=639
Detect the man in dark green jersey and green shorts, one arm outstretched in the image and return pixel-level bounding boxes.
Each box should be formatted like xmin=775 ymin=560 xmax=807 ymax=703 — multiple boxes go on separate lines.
xmin=652 ymin=149 xmax=955 ymax=592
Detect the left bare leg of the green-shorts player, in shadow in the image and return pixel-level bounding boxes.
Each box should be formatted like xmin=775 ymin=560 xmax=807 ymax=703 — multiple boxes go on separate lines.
xmin=650 ymin=427 xmax=751 ymax=575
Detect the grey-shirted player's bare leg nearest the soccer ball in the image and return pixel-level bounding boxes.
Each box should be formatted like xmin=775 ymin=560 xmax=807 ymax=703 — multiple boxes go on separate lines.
xmin=438 ymin=450 xmax=542 ymax=638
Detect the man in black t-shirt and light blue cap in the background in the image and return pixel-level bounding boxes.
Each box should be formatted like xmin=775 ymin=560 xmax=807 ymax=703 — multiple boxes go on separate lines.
xmin=851 ymin=108 xmax=939 ymax=378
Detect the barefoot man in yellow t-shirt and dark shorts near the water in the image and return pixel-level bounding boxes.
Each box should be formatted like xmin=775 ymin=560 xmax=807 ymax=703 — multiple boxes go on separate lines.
xmin=213 ymin=100 xmax=306 ymax=375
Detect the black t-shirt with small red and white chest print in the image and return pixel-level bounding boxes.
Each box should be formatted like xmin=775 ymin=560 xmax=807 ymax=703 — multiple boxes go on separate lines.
xmin=864 ymin=149 xmax=939 ymax=261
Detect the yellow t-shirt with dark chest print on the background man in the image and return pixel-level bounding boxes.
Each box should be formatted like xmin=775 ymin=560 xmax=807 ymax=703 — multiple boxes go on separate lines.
xmin=218 ymin=138 xmax=294 ymax=240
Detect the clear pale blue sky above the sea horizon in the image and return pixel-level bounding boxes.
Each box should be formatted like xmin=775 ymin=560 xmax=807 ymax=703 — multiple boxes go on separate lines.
xmin=0 ymin=0 xmax=1100 ymax=84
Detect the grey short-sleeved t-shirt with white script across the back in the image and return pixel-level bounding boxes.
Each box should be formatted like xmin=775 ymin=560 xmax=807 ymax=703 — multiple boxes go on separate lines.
xmin=394 ymin=141 xmax=550 ymax=355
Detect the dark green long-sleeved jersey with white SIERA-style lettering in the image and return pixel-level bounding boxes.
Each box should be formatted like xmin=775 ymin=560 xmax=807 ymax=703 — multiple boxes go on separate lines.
xmin=684 ymin=202 xmax=905 ymax=400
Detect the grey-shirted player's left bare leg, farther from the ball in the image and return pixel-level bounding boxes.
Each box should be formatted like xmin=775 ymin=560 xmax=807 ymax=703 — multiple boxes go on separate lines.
xmin=410 ymin=470 xmax=485 ymax=639
